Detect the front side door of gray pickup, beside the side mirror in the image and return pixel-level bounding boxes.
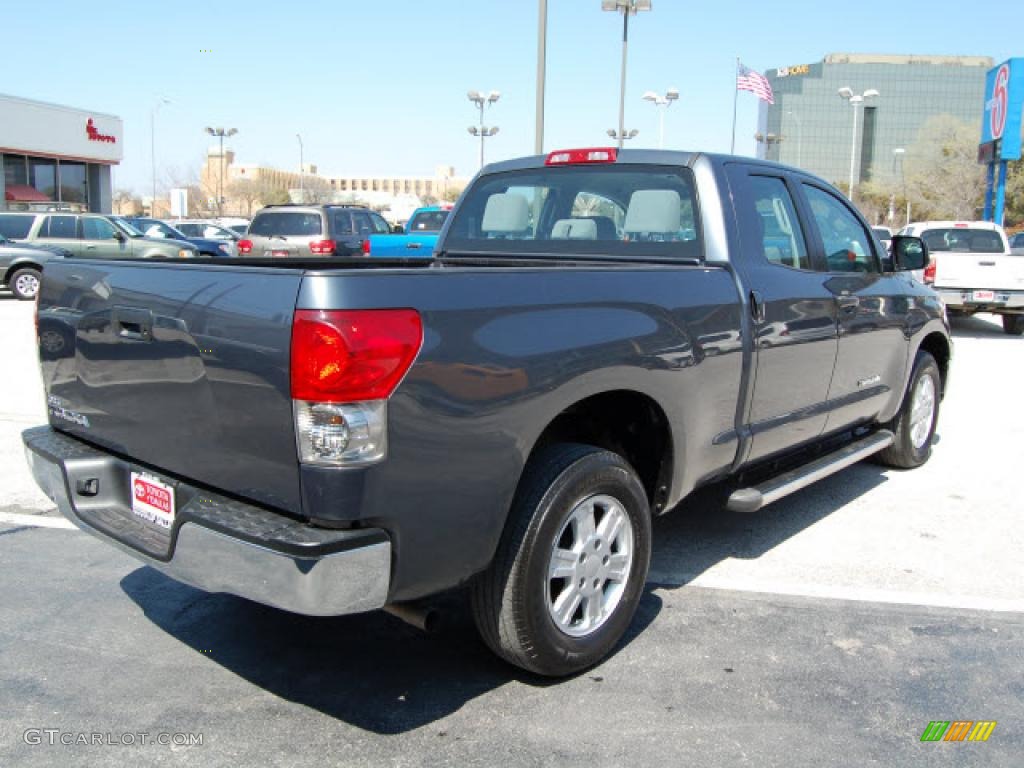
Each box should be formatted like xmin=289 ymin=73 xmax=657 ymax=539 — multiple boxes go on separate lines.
xmin=800 ymin=181 xmax=913 ymax=432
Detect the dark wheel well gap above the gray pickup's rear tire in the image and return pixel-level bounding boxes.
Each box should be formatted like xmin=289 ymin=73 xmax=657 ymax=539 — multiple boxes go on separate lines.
xmin=531 ymin=390 xmax=672 ymax=514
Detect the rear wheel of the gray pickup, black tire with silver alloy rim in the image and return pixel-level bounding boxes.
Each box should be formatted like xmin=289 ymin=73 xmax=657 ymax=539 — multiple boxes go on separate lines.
xmin=470 ymin=443 xmax=651 ymax=677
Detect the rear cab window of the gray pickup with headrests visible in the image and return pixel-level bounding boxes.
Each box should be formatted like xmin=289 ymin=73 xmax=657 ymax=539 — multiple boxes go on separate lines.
xmin=444 ymin=164 xmax=703 ymax=259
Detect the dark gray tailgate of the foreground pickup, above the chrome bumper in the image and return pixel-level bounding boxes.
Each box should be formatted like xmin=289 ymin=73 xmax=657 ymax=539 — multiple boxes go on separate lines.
xmin=39 ymin=260 xmax=302 ymax=514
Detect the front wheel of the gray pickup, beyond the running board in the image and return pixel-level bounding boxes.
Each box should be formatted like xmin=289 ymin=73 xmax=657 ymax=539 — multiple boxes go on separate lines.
xmin=878 ymin=350 xmax=942 ymax=469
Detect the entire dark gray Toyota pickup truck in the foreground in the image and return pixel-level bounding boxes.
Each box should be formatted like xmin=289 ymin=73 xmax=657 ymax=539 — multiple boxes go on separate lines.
xmin=24 ymin=148 xmax=951 ymax=676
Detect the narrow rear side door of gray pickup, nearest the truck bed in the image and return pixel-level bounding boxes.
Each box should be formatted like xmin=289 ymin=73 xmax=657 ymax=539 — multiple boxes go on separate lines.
xmin=727 ymin=164 xmax=838 ymax=461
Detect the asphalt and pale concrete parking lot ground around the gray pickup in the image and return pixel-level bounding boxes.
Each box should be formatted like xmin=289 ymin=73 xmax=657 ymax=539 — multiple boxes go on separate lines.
xmin=0 ymin=296 xmax=1024 ymax=766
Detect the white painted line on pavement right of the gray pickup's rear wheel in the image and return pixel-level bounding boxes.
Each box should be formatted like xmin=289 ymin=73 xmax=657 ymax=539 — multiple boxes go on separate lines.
xmin=648 ymin=571 xmax=1024 ymax=613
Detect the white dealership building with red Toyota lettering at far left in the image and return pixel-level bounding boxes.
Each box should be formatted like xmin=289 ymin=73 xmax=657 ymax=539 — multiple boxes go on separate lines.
xmin=0 ymin=93 xmax=124 ymax=213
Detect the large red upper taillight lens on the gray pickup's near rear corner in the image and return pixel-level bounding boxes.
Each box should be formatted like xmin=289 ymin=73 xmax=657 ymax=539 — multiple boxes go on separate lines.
xmin=292 ymin=309 xmax=423 ymax=402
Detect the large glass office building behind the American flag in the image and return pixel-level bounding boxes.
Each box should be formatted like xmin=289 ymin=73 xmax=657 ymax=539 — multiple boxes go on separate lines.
xmin=755 ymin=53 xmax=992 ymax=187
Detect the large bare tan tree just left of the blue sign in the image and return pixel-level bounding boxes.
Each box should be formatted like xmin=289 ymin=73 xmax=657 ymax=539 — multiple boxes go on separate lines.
xmin=905 ymin=115 xmax=985 ymax=221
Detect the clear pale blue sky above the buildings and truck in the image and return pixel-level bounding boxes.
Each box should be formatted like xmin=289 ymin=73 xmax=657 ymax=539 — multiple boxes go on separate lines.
xmin=0 ymin=0 xmax=1024 ymax=194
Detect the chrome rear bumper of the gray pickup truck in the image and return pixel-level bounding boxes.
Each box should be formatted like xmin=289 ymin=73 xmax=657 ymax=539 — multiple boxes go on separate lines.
xmin=22 ymin=427 xmax=391 ymax=615
